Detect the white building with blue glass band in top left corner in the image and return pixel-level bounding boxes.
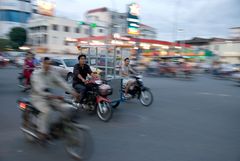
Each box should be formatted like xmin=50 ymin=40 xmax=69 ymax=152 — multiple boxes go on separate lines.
xmin=0 ymin=0 xmax=32 ymax=38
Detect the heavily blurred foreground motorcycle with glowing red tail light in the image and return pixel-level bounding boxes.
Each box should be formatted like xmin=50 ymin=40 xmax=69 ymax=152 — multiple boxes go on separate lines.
xmin=17 ymin=99 xmax=93 ymax=160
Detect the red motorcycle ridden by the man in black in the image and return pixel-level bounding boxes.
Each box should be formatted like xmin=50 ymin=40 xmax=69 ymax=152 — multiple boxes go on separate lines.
xmin=70 ymin=80 xmax=113 ymax=122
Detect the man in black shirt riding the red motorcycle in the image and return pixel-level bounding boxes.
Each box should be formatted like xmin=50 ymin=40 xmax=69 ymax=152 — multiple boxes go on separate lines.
xmin=72 ymin=54 xmax=97 ymax=102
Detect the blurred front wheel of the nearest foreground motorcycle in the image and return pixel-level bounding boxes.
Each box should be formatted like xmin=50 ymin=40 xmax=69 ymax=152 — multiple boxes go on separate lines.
xmin=65 ymin=125 xmax=94 ymax=160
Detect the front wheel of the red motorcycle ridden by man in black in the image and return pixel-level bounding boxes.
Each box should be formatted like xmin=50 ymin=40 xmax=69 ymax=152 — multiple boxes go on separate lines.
xmin=97 ymin=101 xmax=113 ymax=122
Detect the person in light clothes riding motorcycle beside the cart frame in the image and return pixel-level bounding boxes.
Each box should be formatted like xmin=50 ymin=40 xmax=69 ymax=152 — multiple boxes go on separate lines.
xmin=121 ymin=58 xmax=137 ymax=98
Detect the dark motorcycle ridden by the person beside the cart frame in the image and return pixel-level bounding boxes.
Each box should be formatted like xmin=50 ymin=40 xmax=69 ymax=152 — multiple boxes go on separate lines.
xmin=111 ymin=75 xmax=153 ymax=108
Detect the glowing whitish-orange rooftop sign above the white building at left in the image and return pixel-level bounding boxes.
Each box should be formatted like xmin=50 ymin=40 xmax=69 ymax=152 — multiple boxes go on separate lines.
xmin=37 ymin=0 xmax=55 ymax=16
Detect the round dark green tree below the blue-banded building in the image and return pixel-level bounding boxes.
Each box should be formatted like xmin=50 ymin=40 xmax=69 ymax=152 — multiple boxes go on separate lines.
xmin=9 ymin=27 xmax=27 ymax=47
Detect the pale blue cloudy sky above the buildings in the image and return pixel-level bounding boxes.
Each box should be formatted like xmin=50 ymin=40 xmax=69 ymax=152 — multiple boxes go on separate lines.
xmin=55 ymin=0 xmax=240 ymax=41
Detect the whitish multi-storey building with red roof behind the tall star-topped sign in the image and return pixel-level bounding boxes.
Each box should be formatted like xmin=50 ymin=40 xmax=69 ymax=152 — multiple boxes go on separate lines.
xmin=85 ymin=7 xmax=157 ymax=39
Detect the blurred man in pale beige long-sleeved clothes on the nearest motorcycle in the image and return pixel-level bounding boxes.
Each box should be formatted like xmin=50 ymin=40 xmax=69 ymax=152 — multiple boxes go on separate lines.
xmin=30 ymin=57 xmax=79 ymax=140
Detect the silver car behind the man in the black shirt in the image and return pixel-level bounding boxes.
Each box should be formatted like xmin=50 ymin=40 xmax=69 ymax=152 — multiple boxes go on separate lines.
xmin=51 ymin=56 xmax=101 ymax=84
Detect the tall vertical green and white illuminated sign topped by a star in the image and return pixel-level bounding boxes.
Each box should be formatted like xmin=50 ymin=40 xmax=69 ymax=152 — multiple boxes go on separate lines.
xmin=127 ymin=3 xmax=140 ymax=35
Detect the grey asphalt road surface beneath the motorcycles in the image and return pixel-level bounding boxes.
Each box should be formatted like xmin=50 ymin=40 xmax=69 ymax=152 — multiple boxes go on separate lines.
xmin=0 ymin=68 xmax=240 ymax=161
